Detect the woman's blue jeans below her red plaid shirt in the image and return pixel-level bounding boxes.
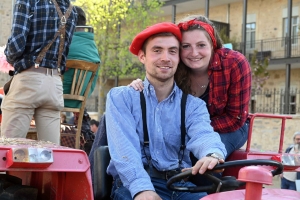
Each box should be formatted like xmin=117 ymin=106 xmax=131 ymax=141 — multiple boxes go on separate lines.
xmin=220 ymin=120 xmax=249 ymax=158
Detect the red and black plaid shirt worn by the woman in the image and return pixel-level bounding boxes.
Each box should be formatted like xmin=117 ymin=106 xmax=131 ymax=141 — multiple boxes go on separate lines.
xmin=208 ymin=48 xmax=251 ymax=133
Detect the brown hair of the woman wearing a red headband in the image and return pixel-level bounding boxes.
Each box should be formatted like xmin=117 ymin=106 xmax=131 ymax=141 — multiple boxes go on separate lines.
xmin=174 ymin=15 xmax=223 ymax=95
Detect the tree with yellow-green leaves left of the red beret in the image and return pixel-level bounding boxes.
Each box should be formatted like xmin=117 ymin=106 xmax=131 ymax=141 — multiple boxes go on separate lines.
xmin=75 ymin=0 xmax=162 ymax=114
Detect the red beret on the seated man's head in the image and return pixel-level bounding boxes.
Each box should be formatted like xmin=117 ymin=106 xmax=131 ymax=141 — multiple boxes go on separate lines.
xmin=129 ymin=22 xmax=181 ymax=55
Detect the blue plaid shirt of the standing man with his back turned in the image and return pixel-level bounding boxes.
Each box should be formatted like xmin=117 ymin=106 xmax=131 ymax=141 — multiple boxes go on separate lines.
xmin=5 ymin=0 xmax=77 ymax=73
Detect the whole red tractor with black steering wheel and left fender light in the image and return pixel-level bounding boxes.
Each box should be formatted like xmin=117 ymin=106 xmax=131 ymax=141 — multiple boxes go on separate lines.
xmin=0 ymin=114 xmax=300 ymax=200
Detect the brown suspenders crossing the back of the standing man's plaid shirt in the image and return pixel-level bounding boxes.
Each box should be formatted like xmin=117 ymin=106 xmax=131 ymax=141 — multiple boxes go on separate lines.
xmin=35 ymin=0 xmax=73 ymax=72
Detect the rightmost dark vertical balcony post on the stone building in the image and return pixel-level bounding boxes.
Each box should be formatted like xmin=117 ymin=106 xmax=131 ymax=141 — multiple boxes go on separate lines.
xmin=284 ymin=0 xmax=293 ymax=114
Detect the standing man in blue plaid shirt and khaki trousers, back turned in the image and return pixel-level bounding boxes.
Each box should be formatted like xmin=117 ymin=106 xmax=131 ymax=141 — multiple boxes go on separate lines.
xmin=1 ymin=0 xmax=77 ymax=144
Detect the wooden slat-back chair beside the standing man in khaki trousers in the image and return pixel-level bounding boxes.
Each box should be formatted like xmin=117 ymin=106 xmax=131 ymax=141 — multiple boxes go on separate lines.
xmin=62 ymin=60 xmax=99 ymax=149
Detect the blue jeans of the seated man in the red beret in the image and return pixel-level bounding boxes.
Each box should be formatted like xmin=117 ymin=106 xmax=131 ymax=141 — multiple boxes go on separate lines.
xmin=111 ymin=178 xmax=207 ymax=200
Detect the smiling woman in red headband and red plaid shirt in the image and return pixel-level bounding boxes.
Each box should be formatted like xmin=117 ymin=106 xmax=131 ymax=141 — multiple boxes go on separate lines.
xmin=130 ymin=16 xmax=251 ymax=157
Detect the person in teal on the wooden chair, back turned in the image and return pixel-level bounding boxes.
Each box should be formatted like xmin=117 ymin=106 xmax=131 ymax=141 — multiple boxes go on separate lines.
xmin=63 ymin=6 xmax=100 ymax=108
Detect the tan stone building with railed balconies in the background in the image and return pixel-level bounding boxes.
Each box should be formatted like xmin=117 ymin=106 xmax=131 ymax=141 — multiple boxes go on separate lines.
xmin=0 ymin=0 xmax=300 ymax=114
